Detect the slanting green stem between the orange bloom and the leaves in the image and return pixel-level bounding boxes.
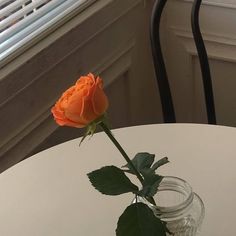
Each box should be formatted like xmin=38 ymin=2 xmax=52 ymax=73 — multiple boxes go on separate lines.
xmin=100 ymin=122 xmax=143 ymax=184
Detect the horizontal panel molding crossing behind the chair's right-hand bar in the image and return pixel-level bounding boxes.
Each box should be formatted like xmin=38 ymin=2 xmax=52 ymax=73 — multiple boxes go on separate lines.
xmin=170 ymin=27 xmax=236 ymax=62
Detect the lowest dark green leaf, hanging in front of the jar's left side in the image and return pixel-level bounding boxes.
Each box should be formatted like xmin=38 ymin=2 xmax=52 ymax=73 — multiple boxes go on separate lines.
xmin=116 ymin=203 xmax=166 ymax=236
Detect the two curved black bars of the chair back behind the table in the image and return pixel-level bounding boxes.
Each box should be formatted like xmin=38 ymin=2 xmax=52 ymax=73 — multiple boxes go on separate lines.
xmin=150 ymin=0 xmax=216 ymax=124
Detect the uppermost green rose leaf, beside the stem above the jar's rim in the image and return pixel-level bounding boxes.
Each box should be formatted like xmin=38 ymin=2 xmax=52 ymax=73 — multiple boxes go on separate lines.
xmin=123 ymin=152 xmax=155 ymax=174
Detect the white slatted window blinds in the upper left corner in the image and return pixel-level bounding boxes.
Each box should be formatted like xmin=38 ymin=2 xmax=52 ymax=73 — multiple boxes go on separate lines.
xmin=0 ymin=0 xmax=93 ymax=62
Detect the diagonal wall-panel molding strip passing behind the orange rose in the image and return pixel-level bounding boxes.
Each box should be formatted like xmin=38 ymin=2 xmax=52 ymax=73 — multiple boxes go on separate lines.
xmin=0 ymin=41 xmax=135 ymax=172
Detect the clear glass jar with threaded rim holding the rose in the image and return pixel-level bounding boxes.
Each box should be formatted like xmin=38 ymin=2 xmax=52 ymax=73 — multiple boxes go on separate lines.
xmin=134 ymin=176 xmax=205 ymax=236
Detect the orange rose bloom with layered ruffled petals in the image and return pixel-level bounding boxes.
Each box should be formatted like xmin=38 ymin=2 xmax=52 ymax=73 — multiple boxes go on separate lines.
xmin=51 ymin=73 xmax=108 ymax=128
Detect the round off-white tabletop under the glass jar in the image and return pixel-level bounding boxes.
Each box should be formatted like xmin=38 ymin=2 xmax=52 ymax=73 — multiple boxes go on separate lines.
xmin=0 ymin=124 xmax=236 ymax=236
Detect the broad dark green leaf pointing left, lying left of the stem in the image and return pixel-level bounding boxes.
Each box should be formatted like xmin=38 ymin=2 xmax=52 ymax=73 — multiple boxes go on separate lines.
xmin=88 ymin=166 xmax=138 ymax=195
